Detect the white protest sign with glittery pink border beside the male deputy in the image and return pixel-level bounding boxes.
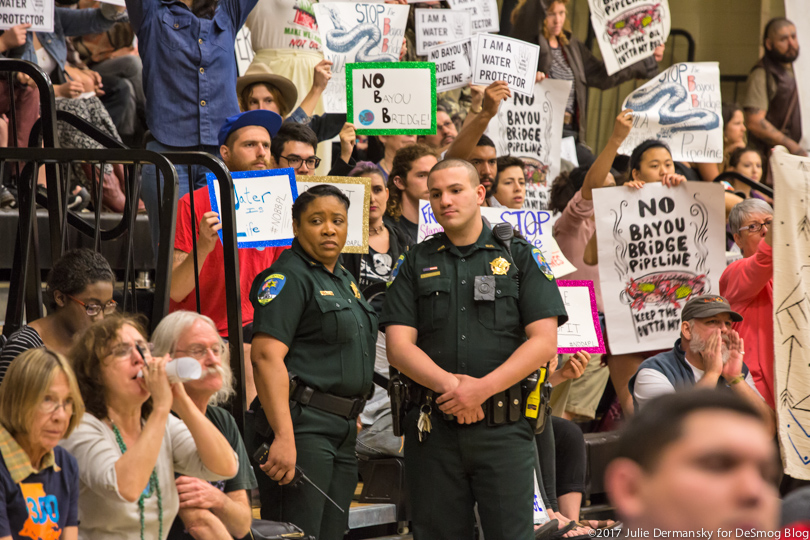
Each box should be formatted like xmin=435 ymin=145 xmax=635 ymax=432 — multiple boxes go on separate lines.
xmin=557 ymin=280 xmax=605 ymax=354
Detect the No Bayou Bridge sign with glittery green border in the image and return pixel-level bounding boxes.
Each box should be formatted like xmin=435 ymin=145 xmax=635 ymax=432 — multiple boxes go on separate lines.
xmin=346 ymin=62 xmax=436 ymax=135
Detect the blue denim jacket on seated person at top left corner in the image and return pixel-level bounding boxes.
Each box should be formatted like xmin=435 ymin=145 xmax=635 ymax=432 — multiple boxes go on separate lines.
xmin=22 ymin=7 xmax=115 ymax=78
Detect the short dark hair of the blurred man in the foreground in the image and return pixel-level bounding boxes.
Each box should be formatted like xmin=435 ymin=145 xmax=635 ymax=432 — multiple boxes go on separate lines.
xmin=613 ymin=389 xmax=765 ymax=472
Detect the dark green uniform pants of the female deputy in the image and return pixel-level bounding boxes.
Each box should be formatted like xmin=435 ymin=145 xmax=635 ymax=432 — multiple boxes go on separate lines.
xmin=254 ymin=405 xmax=357 ymax=540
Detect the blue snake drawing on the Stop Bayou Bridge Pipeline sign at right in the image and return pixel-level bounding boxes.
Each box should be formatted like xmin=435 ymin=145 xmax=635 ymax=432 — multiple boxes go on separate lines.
xmin=625 ymin=82 xmax=720 ymax=131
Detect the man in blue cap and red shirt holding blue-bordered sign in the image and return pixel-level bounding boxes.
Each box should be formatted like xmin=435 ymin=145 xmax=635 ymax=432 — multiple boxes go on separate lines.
xmin=169 ymin=110 xmax=286 ymax=401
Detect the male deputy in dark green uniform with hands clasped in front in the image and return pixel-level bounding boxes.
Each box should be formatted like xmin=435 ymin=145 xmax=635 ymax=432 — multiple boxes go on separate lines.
xmin=380 ymin=159 xmax=568 ymax=540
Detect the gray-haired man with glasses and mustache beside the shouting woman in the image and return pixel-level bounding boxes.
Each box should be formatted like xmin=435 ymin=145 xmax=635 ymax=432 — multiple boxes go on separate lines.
xmin=152 ymin=311 xmax=258 ymax=540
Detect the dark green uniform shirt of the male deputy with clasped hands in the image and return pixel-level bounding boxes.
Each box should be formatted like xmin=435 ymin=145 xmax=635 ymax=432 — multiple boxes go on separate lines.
xmin=380 ymin=221 xmax=568 ymax=377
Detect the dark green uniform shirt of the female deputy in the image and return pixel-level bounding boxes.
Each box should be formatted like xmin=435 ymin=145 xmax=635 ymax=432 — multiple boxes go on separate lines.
xmin=250 ymin=240 xmax=377 ymax=397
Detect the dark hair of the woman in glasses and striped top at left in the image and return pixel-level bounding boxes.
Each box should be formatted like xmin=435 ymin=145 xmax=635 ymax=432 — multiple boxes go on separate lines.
xmin=46 ymin=248 xmax=115 ymax=309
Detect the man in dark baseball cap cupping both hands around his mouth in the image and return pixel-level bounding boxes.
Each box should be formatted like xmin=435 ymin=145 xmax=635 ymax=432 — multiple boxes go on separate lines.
xmin=629 ymin=294 xmax=773 ymax=427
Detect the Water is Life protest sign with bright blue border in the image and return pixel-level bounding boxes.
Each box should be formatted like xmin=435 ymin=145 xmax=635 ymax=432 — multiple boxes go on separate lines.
xmin=208 ymin=169 xmax=298 ymax=248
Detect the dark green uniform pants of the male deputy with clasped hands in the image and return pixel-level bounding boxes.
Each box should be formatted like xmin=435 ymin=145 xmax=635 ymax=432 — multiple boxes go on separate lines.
xmin=405 ymin=408 xmax=536 ymax=540
